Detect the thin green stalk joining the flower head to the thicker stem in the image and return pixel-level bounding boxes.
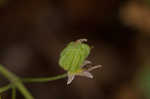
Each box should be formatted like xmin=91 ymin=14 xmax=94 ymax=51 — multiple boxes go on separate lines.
xmin=22 ymin=73 xmax=67 ymax=83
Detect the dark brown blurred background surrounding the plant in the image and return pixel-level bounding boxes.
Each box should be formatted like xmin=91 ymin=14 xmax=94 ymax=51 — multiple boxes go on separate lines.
xmin=0 ymin=0 xmax=150 ymax=99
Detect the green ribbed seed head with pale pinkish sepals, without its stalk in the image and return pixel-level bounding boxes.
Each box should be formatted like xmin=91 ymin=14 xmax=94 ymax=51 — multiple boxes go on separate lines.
xmin=59 ymin=39 xmax=101 ymax=84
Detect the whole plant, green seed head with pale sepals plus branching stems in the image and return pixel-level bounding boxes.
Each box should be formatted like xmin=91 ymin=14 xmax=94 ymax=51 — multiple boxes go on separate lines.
xmin=0 ymin=39 xmax=101 ymax=99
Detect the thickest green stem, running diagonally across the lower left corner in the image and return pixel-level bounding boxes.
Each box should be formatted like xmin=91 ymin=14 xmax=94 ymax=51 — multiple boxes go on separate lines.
xmin=0 ymin=65 xmax=34 ymax=99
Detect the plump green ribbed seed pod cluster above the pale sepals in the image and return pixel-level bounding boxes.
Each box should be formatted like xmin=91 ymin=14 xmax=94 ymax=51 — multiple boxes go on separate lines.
xmin=59 ymin=41 xmax=91 ymax=73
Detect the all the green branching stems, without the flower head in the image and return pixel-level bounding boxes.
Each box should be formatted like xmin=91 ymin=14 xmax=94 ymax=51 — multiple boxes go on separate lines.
xmin=0 ymin=65 xmax=67 ymax=99
